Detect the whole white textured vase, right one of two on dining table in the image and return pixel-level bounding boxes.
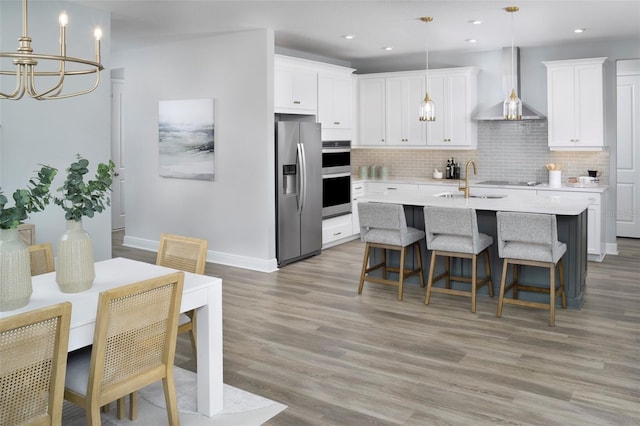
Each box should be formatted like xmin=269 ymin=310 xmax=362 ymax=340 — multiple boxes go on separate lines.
xmin=56 ymin=220 xmax=96 ymax=293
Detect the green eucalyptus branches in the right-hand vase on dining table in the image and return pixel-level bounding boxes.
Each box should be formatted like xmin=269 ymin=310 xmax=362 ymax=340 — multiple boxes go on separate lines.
xmin=54 ymin=155 xmax=115 ymax=222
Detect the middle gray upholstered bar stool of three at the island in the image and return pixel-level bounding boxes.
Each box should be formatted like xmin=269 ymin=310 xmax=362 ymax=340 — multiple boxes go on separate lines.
xmin=424 ymin=206 xmax=493 ymax=312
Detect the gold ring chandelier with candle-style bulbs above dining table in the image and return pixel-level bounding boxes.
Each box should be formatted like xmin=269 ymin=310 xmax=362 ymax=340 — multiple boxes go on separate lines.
xmin=0 ymin=0 xmax=104 ymax=100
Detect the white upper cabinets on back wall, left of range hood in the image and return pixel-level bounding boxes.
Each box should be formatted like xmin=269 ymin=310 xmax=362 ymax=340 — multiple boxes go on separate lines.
xmin=358 ymin=67 xmax=477 ymax=149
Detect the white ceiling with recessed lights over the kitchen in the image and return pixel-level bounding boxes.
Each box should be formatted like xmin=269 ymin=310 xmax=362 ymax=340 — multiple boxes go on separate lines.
xmin=71 ymin=0 xmax=640 ymax=68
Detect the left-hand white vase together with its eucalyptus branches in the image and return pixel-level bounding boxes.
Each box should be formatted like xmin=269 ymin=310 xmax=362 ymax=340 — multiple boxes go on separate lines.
xmin=0 ymin=166 xmax=57 ymax=311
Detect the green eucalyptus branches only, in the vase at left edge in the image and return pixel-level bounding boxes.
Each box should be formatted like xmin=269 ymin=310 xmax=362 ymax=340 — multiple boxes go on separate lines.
xmin=0 ymin=165 xmax=58 ymax=229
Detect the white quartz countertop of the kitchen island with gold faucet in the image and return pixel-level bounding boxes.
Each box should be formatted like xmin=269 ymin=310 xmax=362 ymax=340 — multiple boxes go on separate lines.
xmin=358 ymin=185 xmax=590 ymax=216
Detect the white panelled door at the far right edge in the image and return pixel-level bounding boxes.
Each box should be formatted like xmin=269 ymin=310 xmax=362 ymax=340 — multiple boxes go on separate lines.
xmin=616 ymin=59 xmax=640 ymax=238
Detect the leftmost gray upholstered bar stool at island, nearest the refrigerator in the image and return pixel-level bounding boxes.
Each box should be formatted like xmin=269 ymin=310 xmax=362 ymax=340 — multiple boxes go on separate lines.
xmin=358 ymin=203 xmax=425 ymax=300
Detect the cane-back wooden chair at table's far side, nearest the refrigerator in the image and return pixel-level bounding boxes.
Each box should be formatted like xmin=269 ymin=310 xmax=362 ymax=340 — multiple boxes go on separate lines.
xmin=156 ymin=233 xmax=208 ymax=359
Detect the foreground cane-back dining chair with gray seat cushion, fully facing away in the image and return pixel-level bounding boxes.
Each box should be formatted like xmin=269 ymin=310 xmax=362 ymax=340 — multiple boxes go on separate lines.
xmin=64 ymin=272 xmax=184 ymax=425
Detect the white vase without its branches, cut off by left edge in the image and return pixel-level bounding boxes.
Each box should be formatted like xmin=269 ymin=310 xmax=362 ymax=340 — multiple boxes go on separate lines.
xmin=0 ymin=229 xmax=33 ymax=312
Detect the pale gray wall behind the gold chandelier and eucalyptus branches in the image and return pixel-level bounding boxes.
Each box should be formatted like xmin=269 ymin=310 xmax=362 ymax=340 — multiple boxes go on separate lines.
xmin=0 ymin=1 xmax=111 ymax=260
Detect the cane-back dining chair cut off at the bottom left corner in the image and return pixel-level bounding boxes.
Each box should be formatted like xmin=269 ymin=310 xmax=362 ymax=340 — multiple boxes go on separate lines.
xmin=0 ymin=302 xmax=71 ymax=425
